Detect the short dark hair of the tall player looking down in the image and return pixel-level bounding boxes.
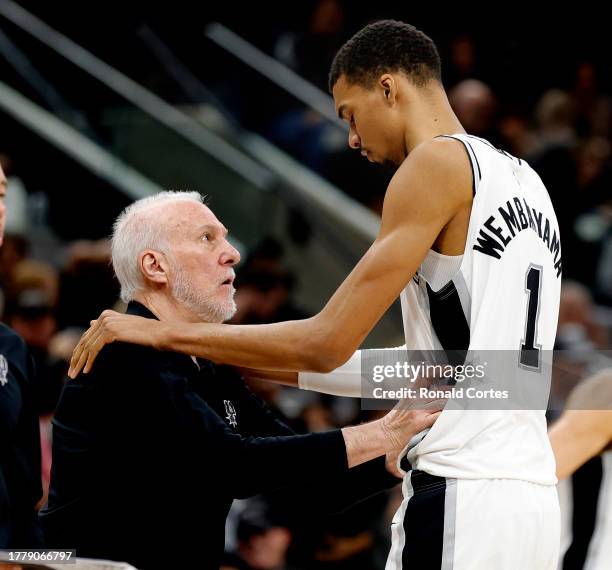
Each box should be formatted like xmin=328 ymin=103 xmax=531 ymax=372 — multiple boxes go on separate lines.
xmin=329 ymin=20 xmax=441 ymax=92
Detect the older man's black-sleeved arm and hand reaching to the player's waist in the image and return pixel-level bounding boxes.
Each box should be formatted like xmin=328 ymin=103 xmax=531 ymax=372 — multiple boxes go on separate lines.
xmin=176 ymin=386 xmax=440 ymax=498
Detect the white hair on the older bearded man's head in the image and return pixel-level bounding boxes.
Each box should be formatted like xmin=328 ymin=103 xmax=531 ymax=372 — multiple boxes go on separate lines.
xmin=111 ymin=191 xmax=204 ymax=303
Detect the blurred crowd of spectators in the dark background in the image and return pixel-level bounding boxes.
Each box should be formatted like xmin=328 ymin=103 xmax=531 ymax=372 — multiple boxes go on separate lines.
xmin=0 ymin=0 xmax=612 ymax=570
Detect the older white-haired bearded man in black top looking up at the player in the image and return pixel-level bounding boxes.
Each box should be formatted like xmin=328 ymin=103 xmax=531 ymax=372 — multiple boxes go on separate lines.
xmin=41 ymin=192 xmax=438 ymax=568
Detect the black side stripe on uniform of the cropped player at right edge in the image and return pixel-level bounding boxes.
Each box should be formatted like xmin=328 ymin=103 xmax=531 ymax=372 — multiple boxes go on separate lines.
xmin=562 ymin=456 xmax=603 ymax=570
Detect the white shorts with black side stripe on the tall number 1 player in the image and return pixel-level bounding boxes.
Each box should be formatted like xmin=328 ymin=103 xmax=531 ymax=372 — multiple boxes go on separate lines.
xmin=386 ymin=471 xmax=560 ymax=570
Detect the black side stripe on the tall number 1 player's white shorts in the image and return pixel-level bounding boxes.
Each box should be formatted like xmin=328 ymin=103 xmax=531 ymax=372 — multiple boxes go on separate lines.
xmin=398 ymin=471 xmax=446 ymax=570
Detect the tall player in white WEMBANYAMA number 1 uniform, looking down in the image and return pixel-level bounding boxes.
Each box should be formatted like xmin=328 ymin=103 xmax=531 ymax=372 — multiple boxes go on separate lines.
xmin=70 ymin=20 xmax=561 ymax=570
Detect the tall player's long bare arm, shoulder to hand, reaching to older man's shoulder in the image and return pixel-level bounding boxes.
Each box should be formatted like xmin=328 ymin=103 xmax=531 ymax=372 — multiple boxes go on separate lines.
xmin=70 ymin=139 xmax=471 ymax=375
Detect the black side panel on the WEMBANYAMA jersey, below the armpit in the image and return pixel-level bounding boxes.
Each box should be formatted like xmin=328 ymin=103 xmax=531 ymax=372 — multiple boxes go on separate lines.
xmin=427 ymin=281 xmax=470 ymax=365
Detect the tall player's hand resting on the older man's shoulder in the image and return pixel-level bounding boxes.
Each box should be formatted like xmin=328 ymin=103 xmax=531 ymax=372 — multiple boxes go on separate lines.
xmin=68 ymin=311 xmax=162 ymax=378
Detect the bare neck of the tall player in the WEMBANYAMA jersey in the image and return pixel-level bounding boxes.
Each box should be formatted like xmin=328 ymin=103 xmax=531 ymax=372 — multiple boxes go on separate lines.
xmin=404 ymin=89 xmax=465 ymax=152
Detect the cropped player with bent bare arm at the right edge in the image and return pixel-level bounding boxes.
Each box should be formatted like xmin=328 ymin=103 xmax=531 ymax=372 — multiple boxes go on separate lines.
xmin=549 ymin=369 xmax=612 ymax=570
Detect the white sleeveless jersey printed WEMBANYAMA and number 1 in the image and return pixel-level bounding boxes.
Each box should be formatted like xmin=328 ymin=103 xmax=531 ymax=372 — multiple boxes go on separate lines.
xmin=401 ymin=135 xmax=561 ymax=485
